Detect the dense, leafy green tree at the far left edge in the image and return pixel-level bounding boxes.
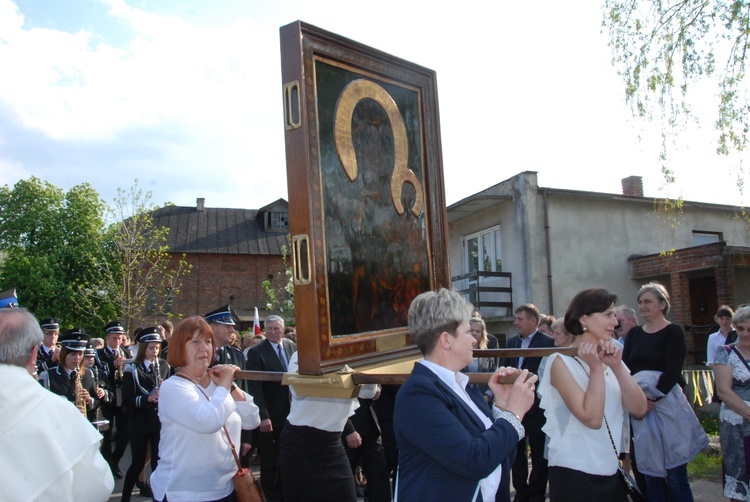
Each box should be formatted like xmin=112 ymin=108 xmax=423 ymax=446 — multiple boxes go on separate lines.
xmin=0 ymin=177 xmax=114 ymax=333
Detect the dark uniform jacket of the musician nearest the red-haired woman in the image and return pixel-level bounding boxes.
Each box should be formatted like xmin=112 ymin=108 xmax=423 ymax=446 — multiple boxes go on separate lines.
xmin=122 ymin=359 xmax=169 ymax=432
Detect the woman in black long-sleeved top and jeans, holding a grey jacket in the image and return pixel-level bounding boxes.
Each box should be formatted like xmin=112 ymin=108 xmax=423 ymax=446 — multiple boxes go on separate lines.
xmin=622 ymin=282 xmax=693 ymax=502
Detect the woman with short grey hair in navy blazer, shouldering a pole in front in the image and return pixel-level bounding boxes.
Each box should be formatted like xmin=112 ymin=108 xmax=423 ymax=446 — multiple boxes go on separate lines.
xmin=394 ymin=289 xmax=537 ymax=502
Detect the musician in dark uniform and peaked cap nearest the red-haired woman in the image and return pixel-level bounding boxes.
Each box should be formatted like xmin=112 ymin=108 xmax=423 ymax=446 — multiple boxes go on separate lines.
xmin=122 ymin=327 xmax=169 ymax=501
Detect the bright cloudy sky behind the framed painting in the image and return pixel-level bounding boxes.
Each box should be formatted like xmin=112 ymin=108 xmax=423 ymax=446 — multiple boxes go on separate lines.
xmin=0 ymin=0 xmax=743 ymax=208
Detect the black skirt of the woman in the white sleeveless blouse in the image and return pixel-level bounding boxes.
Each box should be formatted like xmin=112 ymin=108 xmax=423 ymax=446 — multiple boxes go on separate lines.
xmin=549 ymin=466 xmax=628 ymax=502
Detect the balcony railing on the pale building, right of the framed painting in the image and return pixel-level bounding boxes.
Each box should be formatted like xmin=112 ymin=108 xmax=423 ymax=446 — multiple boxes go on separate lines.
xmin=451 ymin=271 xmax=513 ymax=317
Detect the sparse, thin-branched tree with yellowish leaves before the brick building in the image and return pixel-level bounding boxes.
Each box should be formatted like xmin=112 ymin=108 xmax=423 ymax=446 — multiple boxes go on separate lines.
xmin=76 ymin=179 xmax=192 ymax=331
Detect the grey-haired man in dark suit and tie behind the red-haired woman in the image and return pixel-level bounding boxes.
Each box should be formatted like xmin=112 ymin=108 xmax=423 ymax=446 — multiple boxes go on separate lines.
xmin=247 ymin=315 xmax=297 ymax=502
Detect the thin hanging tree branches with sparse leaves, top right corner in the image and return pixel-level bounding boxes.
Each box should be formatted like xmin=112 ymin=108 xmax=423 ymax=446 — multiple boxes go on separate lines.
xmin=604 ymin=0 xmax=750 ymax=190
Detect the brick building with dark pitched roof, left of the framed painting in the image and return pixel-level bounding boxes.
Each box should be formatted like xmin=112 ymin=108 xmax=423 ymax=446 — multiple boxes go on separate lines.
xmin=144 ymin=198 xmax=291 ymax=330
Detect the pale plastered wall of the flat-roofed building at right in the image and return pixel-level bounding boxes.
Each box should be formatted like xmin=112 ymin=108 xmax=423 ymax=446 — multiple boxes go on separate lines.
xmin=448 ymin=172 xmax=750 ymax=336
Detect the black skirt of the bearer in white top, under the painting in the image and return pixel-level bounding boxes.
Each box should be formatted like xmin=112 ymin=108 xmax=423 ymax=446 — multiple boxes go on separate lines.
xmin=279 ymin=422 xmax=357 ymax=502
